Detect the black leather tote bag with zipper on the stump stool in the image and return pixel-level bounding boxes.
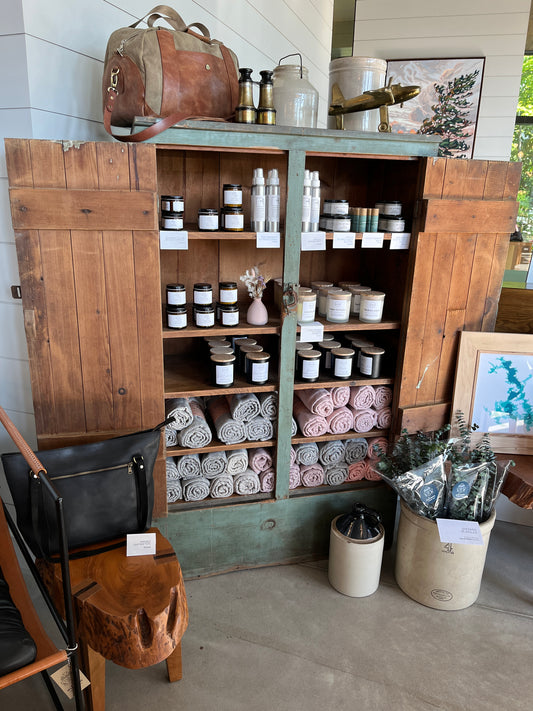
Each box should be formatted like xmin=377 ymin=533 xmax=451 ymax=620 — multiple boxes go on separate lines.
xmin=2 ymin=422 xmax=166 ymax=559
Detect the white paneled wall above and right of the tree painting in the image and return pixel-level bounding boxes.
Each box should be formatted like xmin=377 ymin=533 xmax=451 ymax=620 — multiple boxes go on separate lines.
xmin=354 ymin=0 xmax=531 ymax=160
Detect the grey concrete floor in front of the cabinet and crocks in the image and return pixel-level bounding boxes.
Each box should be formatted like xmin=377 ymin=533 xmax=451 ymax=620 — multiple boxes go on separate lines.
xmin=0 ymin=521 xmax=533 ymax=711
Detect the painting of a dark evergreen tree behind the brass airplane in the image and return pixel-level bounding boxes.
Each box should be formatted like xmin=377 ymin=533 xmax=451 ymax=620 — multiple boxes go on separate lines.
xmin=387 ymin=57 xmax=485 ymax=158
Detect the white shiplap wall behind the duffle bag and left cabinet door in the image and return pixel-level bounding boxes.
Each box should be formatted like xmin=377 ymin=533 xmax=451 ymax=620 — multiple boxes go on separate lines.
xmin=0 ymin=0 xmax=333 ymax=452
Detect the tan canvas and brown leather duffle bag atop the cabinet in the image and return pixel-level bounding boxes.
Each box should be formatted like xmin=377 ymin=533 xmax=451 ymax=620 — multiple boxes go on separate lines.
xmin=102 ymin=5 xmax=239 ymax=141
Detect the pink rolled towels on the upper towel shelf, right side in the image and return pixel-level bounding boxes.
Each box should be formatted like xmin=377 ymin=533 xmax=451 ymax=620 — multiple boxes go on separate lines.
xmin=293 ymin=385 xmax=392 ymax=438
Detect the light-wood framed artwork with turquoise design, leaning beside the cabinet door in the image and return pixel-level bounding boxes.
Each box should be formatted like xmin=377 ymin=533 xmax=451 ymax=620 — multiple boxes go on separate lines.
xmin=452 ymin=331 xmax=533 ymax=454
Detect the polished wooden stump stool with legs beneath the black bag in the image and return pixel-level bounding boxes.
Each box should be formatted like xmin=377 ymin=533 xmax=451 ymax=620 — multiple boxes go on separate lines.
xmin=37 ymin=528 xmax=188 ymax=711
